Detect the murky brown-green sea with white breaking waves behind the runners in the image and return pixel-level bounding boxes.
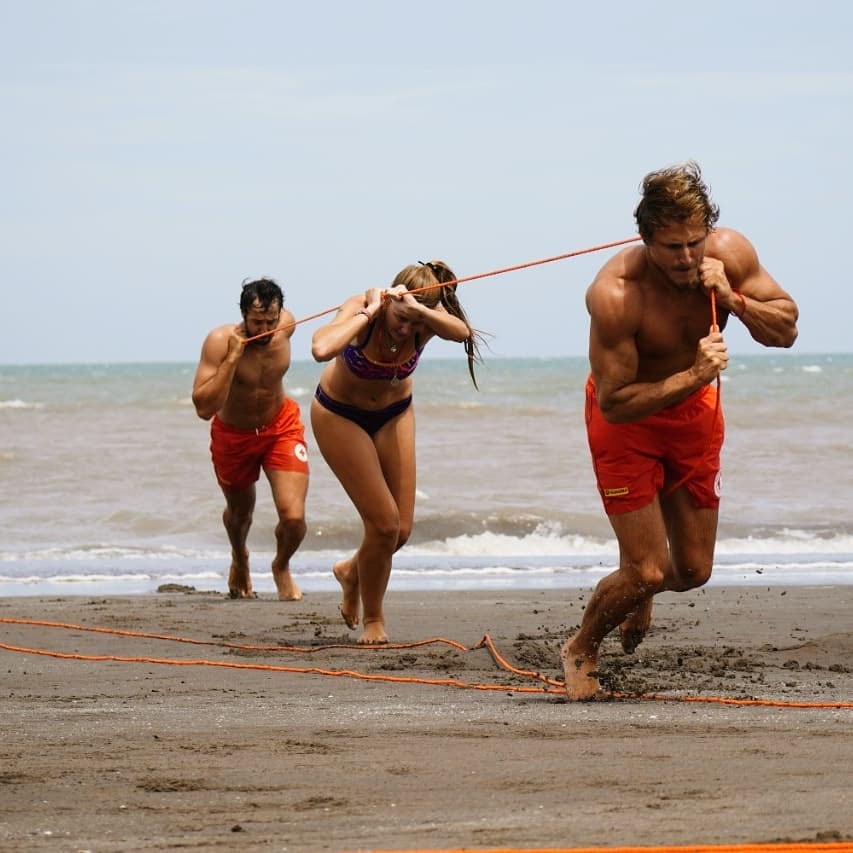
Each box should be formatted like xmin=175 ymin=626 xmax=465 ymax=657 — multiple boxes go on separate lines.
xmin=0 ymin=351 xmax=853 ymax=596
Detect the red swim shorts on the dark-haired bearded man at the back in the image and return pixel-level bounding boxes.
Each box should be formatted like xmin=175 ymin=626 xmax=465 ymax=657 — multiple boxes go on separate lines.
xmin=210 ymin=397 xmax=308 ymax=492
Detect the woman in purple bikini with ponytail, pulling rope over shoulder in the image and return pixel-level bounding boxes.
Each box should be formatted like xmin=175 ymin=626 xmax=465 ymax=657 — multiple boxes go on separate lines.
xmin=311 ymin=261 xmax=479 ymax=643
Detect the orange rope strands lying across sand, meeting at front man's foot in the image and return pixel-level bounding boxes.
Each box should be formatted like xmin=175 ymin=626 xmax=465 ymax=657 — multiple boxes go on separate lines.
xmin=0 ymin=617 xmax=853 ymax=709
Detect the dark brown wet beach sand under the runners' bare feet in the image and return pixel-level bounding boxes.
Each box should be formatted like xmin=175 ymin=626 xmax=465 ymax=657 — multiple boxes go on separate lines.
xmin=0 ymin=578 xmax=853 ymax=853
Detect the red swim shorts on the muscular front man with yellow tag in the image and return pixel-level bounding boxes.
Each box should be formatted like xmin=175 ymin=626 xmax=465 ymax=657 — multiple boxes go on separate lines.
xmin=586 ymin=377 xmax=725 ymax=515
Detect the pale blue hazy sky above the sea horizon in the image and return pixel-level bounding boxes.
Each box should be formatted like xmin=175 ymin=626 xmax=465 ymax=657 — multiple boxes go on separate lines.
xmin=0 ymin=0 xmax=853 ymax=364
